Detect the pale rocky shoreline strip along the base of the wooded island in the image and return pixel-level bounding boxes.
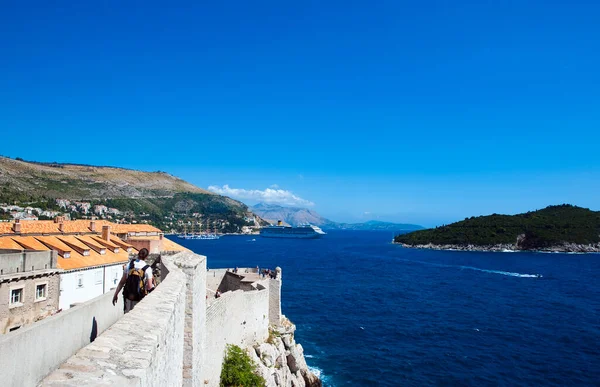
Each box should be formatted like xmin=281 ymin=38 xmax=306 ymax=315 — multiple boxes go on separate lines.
xmin=392 ymin=242 xmax=600 ymax=253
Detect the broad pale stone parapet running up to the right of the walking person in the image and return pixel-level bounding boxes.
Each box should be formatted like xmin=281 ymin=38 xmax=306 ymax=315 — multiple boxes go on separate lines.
xmin=40 ymin=252 xmax=195 ymax=387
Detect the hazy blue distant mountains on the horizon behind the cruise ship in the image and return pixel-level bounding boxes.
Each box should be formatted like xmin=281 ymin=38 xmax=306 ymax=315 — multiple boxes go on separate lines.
xmin=250 ymin=203 xmax=423 ymax=231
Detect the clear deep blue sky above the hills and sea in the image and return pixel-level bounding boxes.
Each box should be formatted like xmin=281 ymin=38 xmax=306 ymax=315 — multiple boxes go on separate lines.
xmin=0 ymin=1 xmax=600 ymax=226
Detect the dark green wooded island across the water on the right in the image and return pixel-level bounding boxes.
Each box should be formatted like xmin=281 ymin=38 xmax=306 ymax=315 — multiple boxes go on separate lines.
xmin=394 ymin=204 xmax=600 ymax=252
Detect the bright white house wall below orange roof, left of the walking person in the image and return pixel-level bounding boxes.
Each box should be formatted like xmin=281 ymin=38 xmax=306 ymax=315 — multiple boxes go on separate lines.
xmin=58 ymin=263 xmax=123 ymax=310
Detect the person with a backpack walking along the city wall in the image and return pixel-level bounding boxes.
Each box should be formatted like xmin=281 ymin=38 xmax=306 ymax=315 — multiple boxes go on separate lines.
xmin=113 ymin=248 xmax=154 ymax=313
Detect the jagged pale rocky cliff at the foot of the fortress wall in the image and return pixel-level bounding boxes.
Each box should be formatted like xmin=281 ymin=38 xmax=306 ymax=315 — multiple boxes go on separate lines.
xmin=248 ymin=317 xmax=322 ymax=387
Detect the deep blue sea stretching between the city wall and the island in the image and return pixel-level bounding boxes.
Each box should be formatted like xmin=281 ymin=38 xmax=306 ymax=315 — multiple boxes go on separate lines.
xmin=169 ymin=231 xmax=600 ymax=386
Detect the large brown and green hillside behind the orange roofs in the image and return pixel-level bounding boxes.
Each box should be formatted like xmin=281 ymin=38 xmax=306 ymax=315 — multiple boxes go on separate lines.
xmin=0 ymin=157 xmax=266 ymax=233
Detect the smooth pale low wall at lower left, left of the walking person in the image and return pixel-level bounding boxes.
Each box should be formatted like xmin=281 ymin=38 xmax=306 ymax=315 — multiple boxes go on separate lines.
xmin=0 ymin=289 xmax=123 ymax=387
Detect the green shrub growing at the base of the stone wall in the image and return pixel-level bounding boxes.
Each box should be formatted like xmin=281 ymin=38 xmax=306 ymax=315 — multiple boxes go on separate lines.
xmin=221 ymin=345 xmax=265 ymax=387
